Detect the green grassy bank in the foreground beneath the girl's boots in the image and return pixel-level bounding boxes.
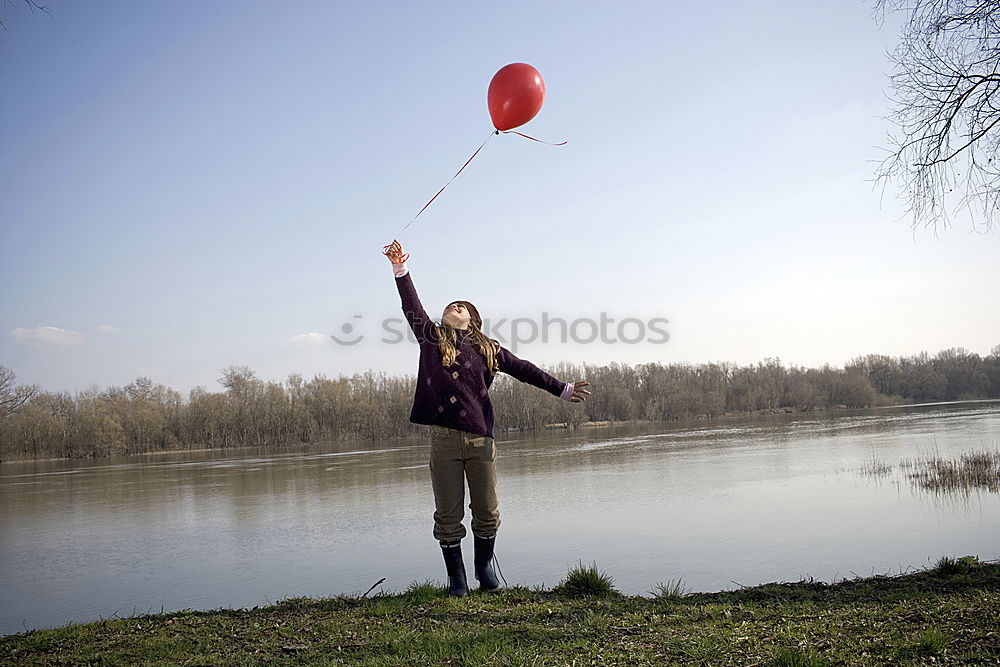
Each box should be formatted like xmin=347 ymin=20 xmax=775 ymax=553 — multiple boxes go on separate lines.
xmin=0 ymin=557 xmax=1000 ymax=666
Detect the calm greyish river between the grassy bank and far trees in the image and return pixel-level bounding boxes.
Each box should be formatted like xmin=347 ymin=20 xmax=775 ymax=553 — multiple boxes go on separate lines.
xmin=0 ymin=401 xmax=1000 ymax=634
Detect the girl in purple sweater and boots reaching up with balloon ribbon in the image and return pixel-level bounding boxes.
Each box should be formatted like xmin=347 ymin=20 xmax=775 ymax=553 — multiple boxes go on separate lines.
xmin=384 ymin=241 xmax=590 ymax=597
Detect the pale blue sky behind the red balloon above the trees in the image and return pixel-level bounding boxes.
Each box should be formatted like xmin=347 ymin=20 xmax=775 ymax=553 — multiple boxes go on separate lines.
xmin=0 ymin=0 xmax=1000 ymax=394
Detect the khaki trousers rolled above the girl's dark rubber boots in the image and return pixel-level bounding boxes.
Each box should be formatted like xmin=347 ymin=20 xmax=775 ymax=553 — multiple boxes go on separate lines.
xmin=431 ymin=426 xmax=500 ymax=542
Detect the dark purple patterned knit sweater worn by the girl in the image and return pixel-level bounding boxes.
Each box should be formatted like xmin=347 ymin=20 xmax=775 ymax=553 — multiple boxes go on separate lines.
xmin=393 ymin=263 xmax=574 ymax=438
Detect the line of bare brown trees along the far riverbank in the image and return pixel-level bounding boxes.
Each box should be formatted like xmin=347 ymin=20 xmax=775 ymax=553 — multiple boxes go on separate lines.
xmin=0 ymin=345 xmax=1000 ymax=460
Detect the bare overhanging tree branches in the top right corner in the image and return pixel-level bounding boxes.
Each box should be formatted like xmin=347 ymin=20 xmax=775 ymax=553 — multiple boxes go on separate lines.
xmin=875 ymin=0 xmax=1000 ymax=232
